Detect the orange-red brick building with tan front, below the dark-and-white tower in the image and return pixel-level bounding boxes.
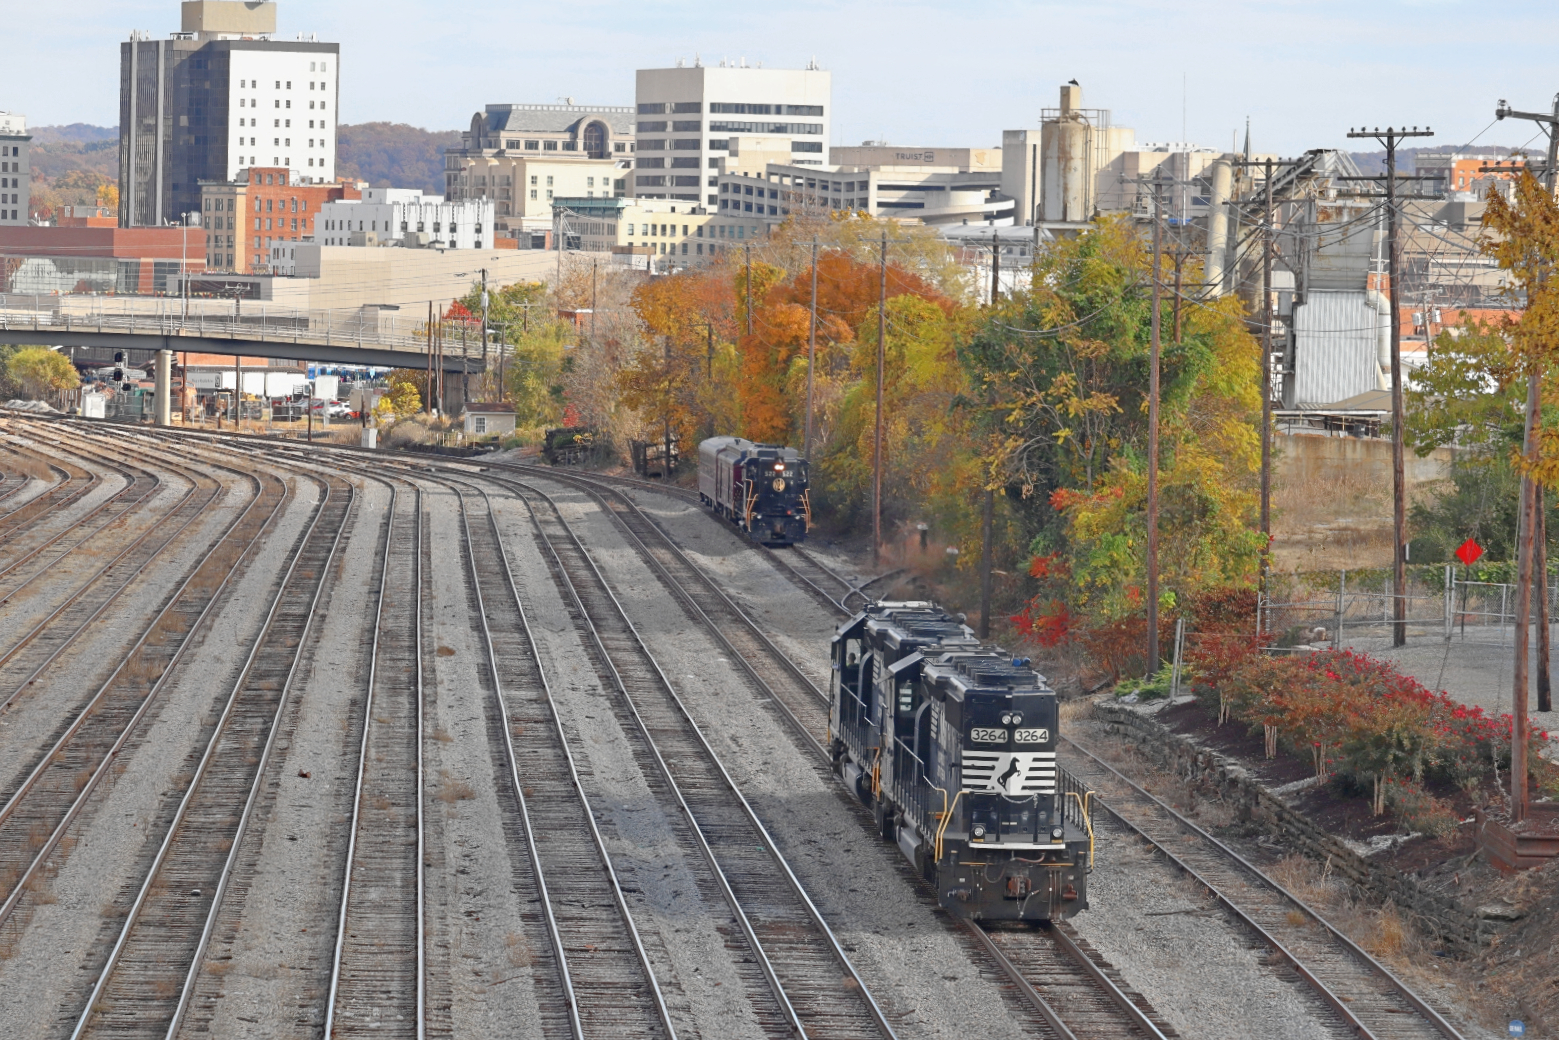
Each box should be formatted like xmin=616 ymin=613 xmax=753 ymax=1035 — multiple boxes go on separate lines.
xmin=201 ymin=167 xmax=365 ymax=274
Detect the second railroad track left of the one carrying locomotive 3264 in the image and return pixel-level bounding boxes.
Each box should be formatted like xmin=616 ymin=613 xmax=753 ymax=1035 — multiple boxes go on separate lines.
xmin=446 ymin=482 xmax=677 ymax=1040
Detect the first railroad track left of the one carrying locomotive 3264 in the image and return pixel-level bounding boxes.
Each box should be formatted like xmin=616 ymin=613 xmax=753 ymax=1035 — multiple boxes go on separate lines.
xmin=521 ymin=485 xmax=895 ymax=1040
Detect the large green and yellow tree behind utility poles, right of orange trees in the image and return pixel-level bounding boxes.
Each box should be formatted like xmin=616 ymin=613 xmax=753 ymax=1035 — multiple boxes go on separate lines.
xmin=965 ymin=220 xmax=1261 ymax=624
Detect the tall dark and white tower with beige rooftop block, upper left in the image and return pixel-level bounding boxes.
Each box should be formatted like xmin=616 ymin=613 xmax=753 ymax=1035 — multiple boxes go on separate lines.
xmin=118 ymin=0 xmax=340 ymax=228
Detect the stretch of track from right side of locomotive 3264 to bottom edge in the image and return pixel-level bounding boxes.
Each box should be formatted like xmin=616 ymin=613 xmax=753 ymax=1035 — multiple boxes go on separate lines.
xmin=1062 ymin=738 xmax=1461 ymax=1040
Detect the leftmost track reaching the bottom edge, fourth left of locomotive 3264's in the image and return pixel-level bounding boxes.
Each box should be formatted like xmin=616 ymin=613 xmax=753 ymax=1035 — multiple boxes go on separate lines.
xmin=72 ymin=476 xmax=355 ymax=1040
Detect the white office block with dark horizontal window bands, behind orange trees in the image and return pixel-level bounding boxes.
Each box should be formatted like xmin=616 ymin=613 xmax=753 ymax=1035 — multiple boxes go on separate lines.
xmin=631 ymin=62 xmax=833 ymax=206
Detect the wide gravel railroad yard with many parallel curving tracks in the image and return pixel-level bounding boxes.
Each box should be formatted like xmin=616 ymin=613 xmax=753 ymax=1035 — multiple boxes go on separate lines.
xmin=0 ymin=416 xmax=1484 ymax=1040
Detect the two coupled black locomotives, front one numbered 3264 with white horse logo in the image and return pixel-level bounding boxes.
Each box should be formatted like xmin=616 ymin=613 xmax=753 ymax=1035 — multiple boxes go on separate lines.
xmin=829 ymin=602 xmax=1093 ymax=921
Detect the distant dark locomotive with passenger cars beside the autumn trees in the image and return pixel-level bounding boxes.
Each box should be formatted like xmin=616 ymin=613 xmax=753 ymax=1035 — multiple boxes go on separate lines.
xmin=698 ymin=437 xmax=812 ymax=546
